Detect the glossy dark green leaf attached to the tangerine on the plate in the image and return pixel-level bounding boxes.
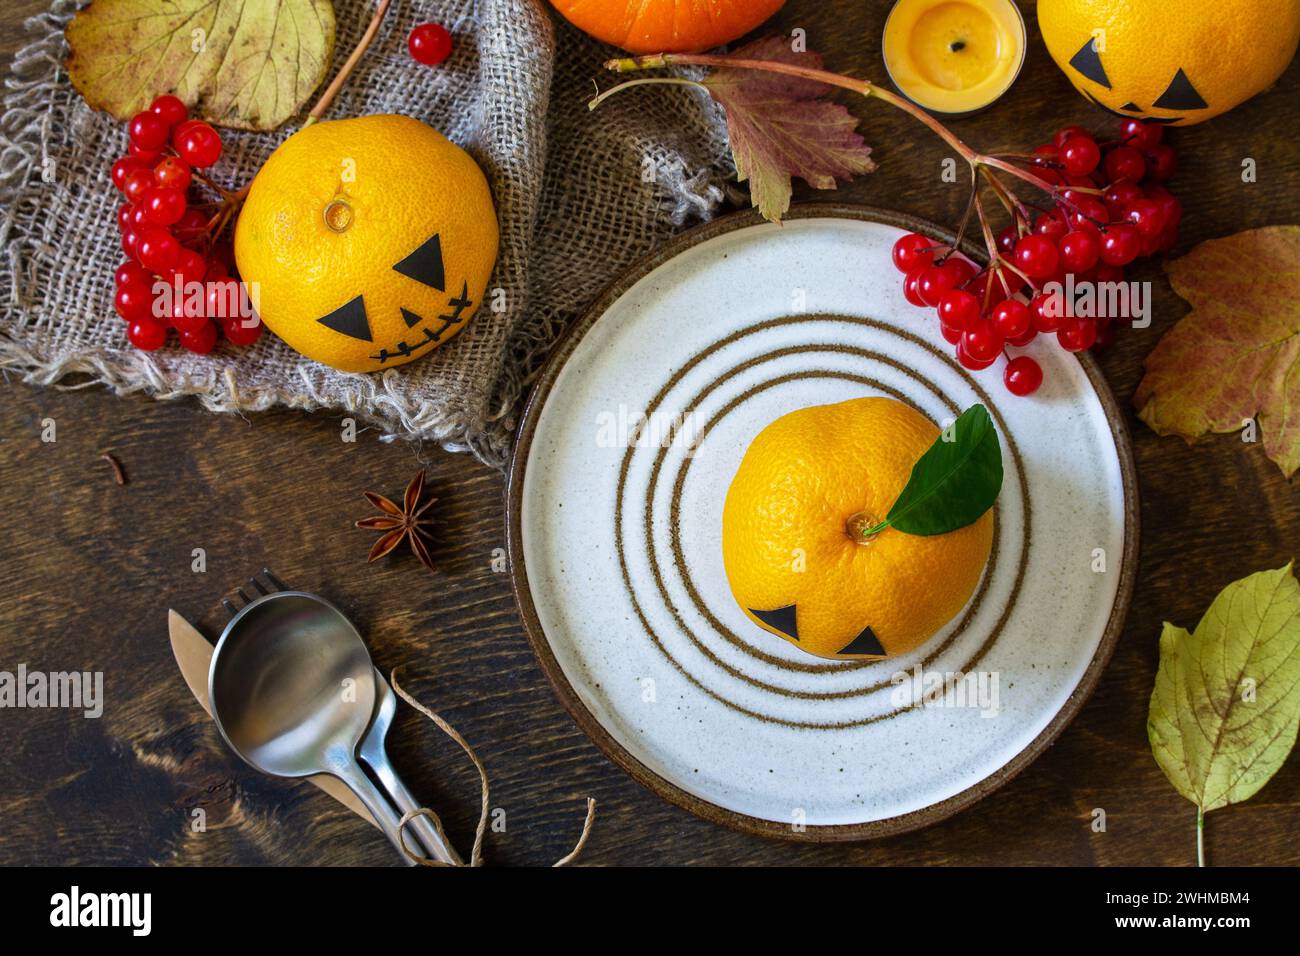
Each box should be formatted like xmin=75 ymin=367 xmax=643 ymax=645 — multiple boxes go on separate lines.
xmin=884 ymin=405 xmax=1002 ymax=535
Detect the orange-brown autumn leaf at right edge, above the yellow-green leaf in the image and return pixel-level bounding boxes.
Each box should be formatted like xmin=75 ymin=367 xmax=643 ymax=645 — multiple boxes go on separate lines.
xmin=1134 ymin=226 xmax=1300 ymax=477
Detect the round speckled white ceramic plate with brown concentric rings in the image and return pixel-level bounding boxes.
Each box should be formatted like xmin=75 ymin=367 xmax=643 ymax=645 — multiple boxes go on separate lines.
xmin=508 ymin=206 xmax=1138 ymax=840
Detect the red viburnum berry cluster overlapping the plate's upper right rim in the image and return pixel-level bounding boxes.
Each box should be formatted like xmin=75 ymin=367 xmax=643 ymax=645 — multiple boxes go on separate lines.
xmin=893 ymin=120 xmax=1182 ymax=395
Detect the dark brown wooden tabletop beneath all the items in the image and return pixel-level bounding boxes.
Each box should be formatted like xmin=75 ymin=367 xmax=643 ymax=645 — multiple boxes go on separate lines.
xmin=0 ymin=0 xmax=1300 ymax=865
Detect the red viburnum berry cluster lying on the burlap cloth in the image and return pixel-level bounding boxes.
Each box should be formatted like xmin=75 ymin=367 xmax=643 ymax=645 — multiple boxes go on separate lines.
xmin=112 ymin=96 xmax=261 ymax=355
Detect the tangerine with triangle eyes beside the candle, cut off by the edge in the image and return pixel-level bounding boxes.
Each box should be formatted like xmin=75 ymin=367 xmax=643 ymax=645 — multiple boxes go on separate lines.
xmin=1037 ymin=0 xmax=1300 ymax=126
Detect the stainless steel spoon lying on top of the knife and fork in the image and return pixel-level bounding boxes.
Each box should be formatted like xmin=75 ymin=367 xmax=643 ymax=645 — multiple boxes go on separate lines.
xmin=208 ymin=591 xmax=411 ymax=862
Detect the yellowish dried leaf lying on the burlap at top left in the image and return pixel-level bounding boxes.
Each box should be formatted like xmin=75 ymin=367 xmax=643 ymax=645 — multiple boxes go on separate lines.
xmin=66 ymin=0 xmax=334 ymax=130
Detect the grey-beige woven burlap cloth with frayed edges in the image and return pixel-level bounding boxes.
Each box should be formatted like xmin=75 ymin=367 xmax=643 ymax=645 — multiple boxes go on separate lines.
xmin=0 ymin=0 xmax=733 ymax=467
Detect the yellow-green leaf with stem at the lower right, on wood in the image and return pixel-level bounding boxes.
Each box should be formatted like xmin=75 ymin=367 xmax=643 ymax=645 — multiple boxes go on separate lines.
xmin=1147 ymin=564 xmax=1300 ymax=813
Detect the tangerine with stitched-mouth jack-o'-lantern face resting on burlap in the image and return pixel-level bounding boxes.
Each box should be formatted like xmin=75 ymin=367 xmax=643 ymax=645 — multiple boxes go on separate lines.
xmin=235 ymin=116 xmax=498 ymax=372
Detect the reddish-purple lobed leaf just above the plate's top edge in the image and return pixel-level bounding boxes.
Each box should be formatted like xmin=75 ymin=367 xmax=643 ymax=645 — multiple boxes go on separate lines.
xmin=702 ymin=36 xmax=876 ymax=222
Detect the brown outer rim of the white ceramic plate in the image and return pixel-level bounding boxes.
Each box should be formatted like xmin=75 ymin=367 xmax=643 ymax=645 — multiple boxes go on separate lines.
xmin=506 ymin=203 xmax=1141 ymax=843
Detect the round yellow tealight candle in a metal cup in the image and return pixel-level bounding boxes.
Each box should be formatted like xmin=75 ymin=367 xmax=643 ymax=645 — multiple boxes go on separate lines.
xmin=883 ymin=0 xmax=1024 ymax=114
